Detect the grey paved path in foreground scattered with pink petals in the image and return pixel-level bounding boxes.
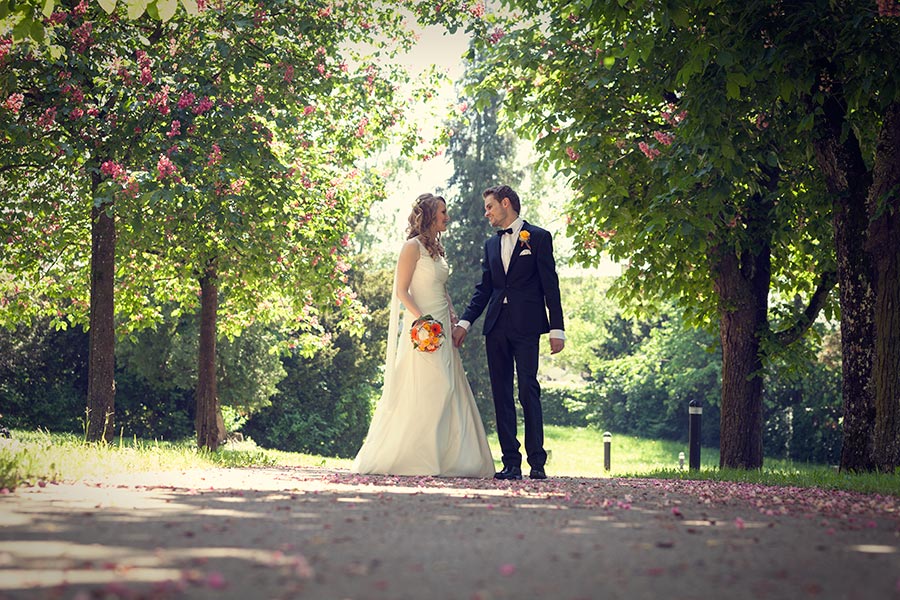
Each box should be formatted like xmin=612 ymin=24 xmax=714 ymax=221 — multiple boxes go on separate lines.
xmin=0 ymin=468 xmax=900 ymax=600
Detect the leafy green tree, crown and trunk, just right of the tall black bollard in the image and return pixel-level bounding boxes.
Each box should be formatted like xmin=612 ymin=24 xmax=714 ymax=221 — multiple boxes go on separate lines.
xmin=440 ymin=2 xmax=834 ymax=468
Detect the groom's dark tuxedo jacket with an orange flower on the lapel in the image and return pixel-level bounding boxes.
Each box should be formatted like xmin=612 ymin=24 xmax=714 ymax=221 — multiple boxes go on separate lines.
xmin=461 ymin=222 xmax=564 ymax=335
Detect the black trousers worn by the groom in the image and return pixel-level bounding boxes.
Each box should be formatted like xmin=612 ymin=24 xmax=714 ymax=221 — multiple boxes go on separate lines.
xmin=485 ymin=307 xmax=547 ymax=468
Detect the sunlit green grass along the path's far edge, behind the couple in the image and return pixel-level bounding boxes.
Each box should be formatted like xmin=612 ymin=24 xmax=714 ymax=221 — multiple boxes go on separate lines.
xmin=0 ymin=426 xmax=900 ymax=496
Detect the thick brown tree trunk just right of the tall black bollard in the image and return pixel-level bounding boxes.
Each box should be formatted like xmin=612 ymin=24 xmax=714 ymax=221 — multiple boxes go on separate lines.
xmin=712 ymin=240 xmax=771 ymax=469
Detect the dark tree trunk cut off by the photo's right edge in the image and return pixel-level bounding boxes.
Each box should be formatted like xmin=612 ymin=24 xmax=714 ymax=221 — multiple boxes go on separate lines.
xmin=867 ymin=102 xmax=900 ymax=473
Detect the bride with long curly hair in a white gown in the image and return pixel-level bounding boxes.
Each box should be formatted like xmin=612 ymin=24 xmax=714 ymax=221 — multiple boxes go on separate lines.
xmin=353 ymin=194 xmax=494 ymax=477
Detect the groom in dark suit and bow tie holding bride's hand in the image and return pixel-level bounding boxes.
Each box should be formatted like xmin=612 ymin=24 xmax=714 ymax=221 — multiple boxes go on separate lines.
xmin=453 ymin=185 xmax=565 ymax=479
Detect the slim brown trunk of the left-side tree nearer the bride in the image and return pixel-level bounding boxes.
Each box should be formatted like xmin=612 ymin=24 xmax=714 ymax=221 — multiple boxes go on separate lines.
xmin=195 ymin=261 xmax=220 ymax=450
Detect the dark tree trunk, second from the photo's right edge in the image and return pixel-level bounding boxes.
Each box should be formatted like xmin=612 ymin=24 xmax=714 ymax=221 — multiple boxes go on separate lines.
xmin=814 ymin=90 xmax=875 ymax=471
